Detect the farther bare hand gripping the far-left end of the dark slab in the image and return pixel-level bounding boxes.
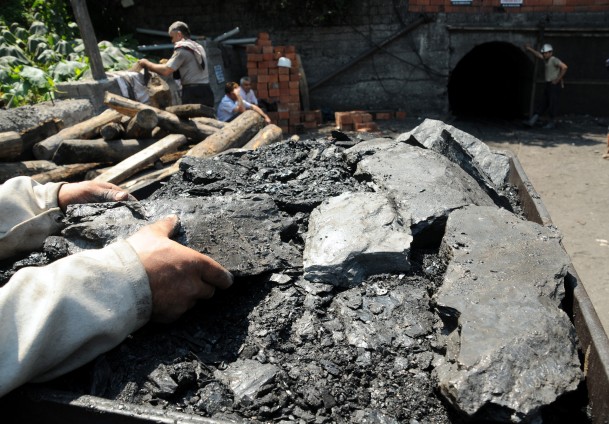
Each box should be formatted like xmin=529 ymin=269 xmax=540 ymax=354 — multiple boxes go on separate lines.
xmin=57 ymin=181 xmax=137 ymax=212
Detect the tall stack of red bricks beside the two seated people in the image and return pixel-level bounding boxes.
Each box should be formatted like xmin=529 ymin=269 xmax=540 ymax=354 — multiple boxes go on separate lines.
xmin=246 ymin=32 xmax=322 ymax=134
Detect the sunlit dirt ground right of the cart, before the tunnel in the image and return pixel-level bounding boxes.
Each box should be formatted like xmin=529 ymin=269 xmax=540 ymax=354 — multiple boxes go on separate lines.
xmin=342 ymin=116 xmax=609 ymax=332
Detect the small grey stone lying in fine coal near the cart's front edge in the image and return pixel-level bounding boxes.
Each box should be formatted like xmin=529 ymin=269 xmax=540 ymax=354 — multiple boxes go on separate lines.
xmin=214 ymin=359 xmax=279 ymax=403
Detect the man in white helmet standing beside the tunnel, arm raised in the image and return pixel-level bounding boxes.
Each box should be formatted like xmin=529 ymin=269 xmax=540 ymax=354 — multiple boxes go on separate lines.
xmin=525 ymin=44 xmax=567 ymax=128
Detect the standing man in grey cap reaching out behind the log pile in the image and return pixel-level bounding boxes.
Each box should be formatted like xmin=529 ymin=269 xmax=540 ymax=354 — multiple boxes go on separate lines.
xmin=138 ymin=21 xmax=214 ymax=107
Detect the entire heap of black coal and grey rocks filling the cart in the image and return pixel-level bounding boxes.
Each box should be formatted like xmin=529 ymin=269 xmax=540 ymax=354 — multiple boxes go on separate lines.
xmin=1 ymin=122 xmax=590 ymax=424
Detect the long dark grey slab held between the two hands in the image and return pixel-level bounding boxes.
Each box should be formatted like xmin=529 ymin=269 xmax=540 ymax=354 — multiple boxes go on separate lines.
xmin=63 ymin=195 xmax=302 ymax=276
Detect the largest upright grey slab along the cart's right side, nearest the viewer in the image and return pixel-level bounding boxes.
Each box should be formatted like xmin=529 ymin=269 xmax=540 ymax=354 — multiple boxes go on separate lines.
xmin=435 ymin=206 xmax=582 ymax=422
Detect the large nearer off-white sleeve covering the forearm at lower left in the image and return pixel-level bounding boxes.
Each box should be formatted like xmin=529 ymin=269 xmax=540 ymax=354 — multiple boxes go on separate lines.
xmin=0 ymin=241 xmax=152 ymax=397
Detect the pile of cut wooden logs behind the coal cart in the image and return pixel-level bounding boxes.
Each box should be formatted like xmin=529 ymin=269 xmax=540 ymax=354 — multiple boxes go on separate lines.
xmin=0 ymin=92 xmax=283 ymax=197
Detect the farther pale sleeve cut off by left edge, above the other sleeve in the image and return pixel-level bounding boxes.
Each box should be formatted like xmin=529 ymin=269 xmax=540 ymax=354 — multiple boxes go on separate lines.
xmin=0 ymin=177 xmax=64 ymax=259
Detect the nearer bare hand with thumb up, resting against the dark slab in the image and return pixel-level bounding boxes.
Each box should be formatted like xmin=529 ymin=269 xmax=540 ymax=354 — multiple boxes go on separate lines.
xmin=127 ymin=215 xmax=233 ymax=322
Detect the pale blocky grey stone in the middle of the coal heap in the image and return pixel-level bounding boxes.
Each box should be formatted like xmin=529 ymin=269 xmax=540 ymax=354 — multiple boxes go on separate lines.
xmin=303 ymin=193 xmax=412 ymax=287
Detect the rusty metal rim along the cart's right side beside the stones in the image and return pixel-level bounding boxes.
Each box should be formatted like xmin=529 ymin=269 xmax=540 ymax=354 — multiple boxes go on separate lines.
xmin=502 ymin=152 xmax=609 ymax=424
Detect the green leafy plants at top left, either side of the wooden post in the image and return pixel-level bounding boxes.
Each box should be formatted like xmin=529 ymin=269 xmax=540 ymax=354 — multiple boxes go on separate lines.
xmin=0 ymin=0 xmax=138 ymax=107
